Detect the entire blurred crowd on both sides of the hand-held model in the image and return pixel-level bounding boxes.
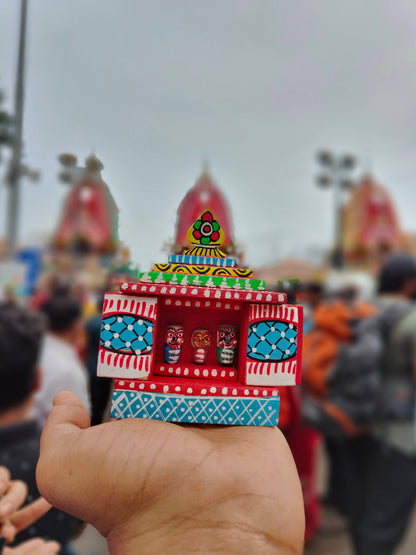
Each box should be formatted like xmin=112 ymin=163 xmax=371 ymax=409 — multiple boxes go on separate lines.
xmin=0 ymin=254 xmax=416 ymax=555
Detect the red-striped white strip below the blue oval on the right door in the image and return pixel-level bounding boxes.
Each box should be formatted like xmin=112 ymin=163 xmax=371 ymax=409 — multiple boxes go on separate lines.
xmin=246 ymin=359 xmax=298 ymax=386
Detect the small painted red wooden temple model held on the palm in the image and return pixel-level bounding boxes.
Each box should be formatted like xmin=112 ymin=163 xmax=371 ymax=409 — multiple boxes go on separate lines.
xmin=98 ymin=210 xmax=303 ymax=426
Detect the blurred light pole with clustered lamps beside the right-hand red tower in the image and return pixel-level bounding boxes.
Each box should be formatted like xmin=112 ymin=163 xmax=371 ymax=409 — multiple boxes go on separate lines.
xmin=317 ymin=151 xmax=356 ymax=269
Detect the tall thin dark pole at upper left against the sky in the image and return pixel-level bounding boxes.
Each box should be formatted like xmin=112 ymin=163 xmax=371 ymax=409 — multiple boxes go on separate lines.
xmin=6 ymin=0 xmax=27 ymax=258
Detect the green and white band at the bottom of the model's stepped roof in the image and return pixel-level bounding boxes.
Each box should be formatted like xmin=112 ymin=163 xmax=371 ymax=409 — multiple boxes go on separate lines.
xmin=139 ymin=272 xmax=266 ymax=291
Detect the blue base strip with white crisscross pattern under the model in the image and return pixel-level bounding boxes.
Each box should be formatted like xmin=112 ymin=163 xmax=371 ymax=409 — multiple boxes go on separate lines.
xmin=111 ymin=390 xmax=280 ymax=426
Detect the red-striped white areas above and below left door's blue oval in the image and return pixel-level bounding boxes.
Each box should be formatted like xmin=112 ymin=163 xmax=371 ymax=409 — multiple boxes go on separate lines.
xmin=97 ymin=293 xmax=158 ymax=380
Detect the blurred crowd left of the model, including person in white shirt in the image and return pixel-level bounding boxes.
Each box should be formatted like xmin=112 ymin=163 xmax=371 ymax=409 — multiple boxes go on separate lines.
xmin=0 ymin=274 xmax=111 ymax=555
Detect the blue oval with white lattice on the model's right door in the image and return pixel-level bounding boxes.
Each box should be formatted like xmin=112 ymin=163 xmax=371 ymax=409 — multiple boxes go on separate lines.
xmin=247 ymin=320 xmax=298 ymax=362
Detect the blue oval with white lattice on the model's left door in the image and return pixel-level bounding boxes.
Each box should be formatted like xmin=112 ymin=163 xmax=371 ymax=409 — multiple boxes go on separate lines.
xmin=100 ymin=314 xmax=153 ymax=355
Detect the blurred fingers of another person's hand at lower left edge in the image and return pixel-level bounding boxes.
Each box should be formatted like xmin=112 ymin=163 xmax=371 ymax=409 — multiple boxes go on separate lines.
xmin=0 ymin=466 xmax=52 ymax=553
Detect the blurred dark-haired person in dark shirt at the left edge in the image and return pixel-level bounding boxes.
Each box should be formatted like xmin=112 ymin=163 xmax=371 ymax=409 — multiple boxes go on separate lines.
xmin=0 ymin=304 xmax=79 ymax=554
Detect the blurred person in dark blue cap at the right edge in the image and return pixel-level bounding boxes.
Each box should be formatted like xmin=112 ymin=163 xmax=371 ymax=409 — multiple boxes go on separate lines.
xmin=353 ymin=254 xmax=416 ymax=555
